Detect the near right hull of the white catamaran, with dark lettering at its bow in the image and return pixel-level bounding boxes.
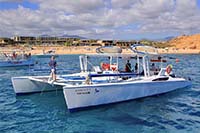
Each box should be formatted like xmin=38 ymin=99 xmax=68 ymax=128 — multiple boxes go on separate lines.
xmin=63 ymin=78 xmax=191 ymax=111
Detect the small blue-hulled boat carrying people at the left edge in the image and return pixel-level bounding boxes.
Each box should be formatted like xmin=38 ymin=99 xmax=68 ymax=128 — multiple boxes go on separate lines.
xmin=0 ymin=50 xmax=34 ymax=67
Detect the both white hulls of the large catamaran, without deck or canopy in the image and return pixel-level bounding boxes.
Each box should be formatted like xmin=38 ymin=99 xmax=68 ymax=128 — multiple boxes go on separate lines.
xmin=12 ymin=77 xmax=191 ymax=111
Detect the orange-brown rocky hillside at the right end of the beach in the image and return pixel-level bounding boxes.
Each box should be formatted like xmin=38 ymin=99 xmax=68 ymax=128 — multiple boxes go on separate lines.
xmin=167 ymin=34 xmax=200 ymax=50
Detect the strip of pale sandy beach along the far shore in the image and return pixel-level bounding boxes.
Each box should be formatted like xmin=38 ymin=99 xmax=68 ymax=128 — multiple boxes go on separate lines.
xmin=0 ymin=46 xmax=200 ymax=55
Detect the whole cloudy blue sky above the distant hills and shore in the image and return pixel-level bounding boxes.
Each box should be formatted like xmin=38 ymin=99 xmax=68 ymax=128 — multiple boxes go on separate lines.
xmin=0 ymin=0 xmax=200 ymax=40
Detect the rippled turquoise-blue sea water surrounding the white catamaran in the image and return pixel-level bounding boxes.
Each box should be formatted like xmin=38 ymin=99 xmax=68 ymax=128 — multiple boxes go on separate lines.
xmin=0 ymin=55 xmax=200 ymax=133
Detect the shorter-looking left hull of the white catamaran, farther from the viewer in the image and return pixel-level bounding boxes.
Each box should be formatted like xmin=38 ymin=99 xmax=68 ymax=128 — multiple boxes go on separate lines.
xmin=12 ymin=76 xmax=62 ymax=95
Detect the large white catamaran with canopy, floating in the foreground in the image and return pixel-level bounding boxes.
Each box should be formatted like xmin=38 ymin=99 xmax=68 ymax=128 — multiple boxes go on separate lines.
xmin=12 ymin=45 xmax=191 ymax=111
